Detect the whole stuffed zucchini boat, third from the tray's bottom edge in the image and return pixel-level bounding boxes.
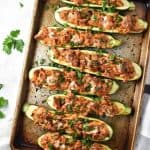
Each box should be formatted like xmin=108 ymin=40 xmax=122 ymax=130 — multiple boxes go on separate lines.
xmin=47 ymin=93 xmax=131 ymax=117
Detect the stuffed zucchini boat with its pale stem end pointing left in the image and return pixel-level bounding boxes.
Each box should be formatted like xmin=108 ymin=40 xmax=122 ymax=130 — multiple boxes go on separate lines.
xmin=23 ymin=104 xmax=113 ymax=142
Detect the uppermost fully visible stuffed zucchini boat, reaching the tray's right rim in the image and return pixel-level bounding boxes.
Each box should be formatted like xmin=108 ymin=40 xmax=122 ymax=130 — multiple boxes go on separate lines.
xmin=55 ymin=7 xmax=147 ymax=34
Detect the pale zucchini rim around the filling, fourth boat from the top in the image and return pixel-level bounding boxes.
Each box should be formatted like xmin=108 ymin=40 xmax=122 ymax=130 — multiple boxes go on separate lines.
xmin=48 ymin=49 xmax=142 ymax=81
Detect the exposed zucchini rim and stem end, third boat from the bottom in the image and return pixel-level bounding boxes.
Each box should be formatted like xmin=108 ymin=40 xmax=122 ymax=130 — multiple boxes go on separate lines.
xmin=47 ymin=94 xmax=132 ymax=116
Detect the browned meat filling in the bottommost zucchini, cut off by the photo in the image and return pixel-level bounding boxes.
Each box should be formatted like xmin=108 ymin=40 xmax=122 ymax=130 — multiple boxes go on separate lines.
xmin=40 ymin=132 xmax=105 ymax=150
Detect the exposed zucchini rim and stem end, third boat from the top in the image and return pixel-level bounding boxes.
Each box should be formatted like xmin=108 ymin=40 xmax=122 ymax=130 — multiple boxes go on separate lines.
xmin=35 ymin=27 xmax=122 ymax=48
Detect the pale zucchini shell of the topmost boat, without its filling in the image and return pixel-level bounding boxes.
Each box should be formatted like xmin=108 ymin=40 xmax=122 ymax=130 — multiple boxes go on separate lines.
xmin=61 ymin=0 xmax=135 ymax=10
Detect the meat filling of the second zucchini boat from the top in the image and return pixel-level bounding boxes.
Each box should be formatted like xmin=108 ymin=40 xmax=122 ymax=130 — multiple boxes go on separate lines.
xmin=60 ymin=8 xmax=143 ymax=33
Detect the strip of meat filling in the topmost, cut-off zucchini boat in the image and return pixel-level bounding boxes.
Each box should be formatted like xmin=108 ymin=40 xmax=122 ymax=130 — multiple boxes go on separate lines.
xmin=70 ymin=0 xmax=123 ymax=7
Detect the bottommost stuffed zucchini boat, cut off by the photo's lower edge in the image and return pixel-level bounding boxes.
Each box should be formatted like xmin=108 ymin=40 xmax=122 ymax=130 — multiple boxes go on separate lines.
xmin=38 ymin=132 xmax=111 ymax=150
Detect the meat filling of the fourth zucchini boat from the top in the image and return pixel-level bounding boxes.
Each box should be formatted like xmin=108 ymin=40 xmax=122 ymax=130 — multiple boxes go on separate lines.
xmin=53 ymin=49 xmax=135 ymax=81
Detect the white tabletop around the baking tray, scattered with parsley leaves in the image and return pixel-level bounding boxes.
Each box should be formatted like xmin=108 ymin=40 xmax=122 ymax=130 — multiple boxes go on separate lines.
xmin=0 ymin=0 xmax=150 ymax=150
